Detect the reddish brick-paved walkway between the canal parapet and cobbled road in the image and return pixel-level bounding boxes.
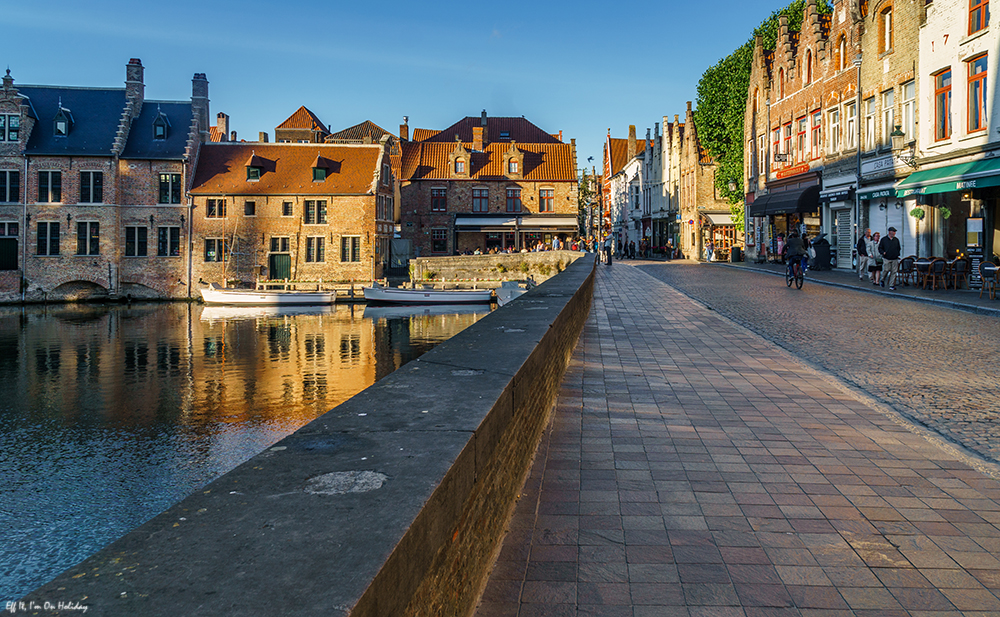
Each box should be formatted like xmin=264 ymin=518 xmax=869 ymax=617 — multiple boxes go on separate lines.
xmin=476 ymin=263 xmax=1000 ymax=617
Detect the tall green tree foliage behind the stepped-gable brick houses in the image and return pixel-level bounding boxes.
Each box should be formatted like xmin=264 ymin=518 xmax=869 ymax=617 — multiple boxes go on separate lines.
xmin=694 ymin=0 xmax=832 ymax=230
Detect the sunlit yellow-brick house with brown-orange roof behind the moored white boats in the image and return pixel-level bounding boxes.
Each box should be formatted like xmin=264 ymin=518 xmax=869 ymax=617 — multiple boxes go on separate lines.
xmin=191 ymin=137 xmax=393 ymax=286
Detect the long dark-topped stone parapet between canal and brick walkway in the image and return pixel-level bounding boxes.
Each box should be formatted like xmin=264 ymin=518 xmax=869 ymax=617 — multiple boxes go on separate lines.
xmin=23 ymin=251 xmax=595 ymax=617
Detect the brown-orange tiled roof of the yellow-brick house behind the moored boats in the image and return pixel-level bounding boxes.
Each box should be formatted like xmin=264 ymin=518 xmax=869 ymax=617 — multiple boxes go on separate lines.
xmin=191 ymin=142 xmax=382 ymax=195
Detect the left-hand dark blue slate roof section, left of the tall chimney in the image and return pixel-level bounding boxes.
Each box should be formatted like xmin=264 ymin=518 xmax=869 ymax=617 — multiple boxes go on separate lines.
xmin=17 ymin=85 xmax=126 ymax=156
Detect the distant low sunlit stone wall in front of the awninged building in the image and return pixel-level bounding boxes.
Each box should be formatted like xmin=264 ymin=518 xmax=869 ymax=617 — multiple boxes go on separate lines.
xmin=410 ymin=251 xmax=594 ymax=283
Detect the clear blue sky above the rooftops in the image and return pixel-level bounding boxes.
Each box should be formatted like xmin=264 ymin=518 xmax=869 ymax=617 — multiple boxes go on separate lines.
xmin=0 ymin=0 xmax=787 ymax=172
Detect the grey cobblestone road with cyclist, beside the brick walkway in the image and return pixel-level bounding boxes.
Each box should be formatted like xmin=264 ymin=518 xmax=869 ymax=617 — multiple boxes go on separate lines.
xmin=639 ymin=262 xmax=1000 ymax=461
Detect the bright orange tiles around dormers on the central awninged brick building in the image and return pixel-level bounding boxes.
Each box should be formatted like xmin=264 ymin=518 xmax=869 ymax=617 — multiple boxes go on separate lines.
xmin=399 ymin=141 xmax=576 ymax=181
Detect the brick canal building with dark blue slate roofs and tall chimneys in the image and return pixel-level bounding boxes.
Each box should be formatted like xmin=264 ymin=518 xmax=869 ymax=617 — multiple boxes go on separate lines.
xmin=0 ymin=58 xmax=208 ymax=301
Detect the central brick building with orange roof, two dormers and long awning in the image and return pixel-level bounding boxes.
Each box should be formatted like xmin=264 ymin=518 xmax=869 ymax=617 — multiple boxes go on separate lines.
xmin=400 ymin=111 xmax=579 ymax=256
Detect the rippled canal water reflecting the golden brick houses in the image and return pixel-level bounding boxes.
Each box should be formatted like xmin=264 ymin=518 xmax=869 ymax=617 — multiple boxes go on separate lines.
xmin=0 ymin=304 xmax=489 ymax=606
